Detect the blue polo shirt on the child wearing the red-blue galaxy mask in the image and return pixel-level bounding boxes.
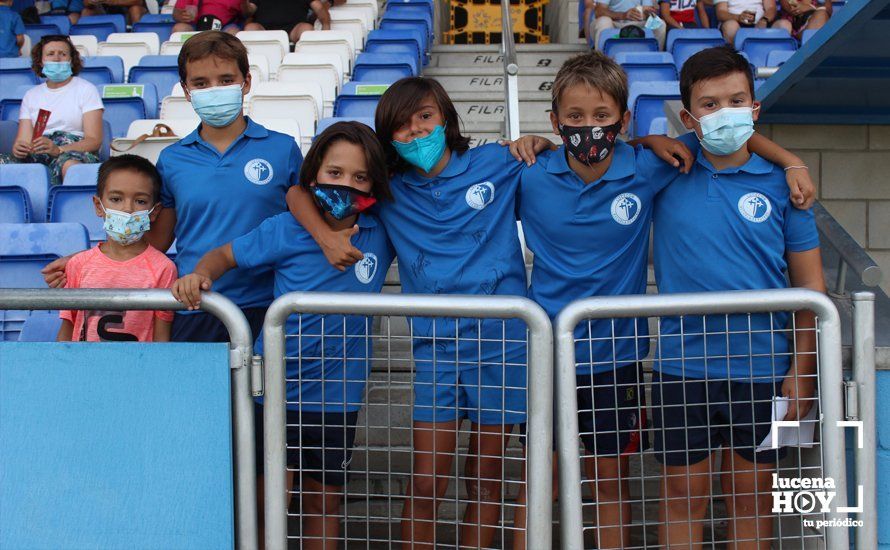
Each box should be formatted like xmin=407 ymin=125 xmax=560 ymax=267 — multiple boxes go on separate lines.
xmin=232 ymin=212 xmax=394 ymax=412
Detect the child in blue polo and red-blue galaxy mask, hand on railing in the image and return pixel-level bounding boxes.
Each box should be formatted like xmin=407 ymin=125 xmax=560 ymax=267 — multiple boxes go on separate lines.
xmin=173 ymin=122 xmax=395 ymax=548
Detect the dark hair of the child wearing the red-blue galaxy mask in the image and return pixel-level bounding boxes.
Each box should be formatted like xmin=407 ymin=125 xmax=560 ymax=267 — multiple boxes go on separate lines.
xmin=300 ymin=121 xmax=392 ymax=204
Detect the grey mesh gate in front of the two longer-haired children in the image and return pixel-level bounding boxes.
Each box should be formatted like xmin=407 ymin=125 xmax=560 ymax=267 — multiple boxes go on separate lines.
xmin=263 ymin=293 xmax=553 ymax=550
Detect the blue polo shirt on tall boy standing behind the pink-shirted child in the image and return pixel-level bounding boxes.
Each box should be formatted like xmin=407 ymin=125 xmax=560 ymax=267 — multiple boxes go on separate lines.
xmin=157 ymin=118 xmax=303 ymax=314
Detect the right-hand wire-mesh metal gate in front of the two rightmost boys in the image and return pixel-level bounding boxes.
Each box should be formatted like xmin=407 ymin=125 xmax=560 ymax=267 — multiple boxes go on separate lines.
xmin=554 ymin=289 xmax=875 ymax=549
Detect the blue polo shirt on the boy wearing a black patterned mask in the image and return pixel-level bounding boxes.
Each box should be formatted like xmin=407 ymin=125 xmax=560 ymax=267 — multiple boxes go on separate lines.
xmin=519 ymin=141 xmax=679 ymax=374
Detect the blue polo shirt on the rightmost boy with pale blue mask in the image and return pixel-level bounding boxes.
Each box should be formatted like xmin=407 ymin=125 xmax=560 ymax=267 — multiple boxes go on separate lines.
xmin=654 ymin=142 xmax=819 ymax=382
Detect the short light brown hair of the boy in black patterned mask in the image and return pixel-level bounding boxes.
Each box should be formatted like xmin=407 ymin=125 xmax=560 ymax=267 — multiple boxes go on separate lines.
xmin=551 ymin=51 xmax=628 ymax=116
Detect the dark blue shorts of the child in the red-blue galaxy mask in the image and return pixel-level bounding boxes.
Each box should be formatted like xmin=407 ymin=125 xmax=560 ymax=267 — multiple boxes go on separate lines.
xmin=254 ymin=403 xmax=358 ymax=487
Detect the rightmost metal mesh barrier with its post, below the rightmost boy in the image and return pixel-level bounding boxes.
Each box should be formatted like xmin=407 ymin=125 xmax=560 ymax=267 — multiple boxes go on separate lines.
xmin=554 ymin=289 xmax=856 ymax=549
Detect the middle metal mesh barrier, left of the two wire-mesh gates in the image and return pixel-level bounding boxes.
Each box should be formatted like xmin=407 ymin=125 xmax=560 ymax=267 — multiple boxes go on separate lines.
xmin=263 ymin=292 xmax=553 ymax=550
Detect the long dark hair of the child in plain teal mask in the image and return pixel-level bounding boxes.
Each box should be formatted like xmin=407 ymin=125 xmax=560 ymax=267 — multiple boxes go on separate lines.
xmin=374 ymin=76 xmax=470 ymax=172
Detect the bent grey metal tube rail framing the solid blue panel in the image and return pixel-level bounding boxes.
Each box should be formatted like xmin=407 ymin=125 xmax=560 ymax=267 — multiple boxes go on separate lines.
xmin=0 ymin=289 xmax=258 ymax=550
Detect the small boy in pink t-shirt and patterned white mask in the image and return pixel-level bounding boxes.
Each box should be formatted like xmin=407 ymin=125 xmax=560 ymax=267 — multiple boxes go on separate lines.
xmin=56 ymin=155 xmax=176 ymax=342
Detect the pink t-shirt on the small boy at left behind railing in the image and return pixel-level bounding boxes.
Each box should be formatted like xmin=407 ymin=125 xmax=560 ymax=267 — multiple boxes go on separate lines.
xmin=59 ymin=245 xmax=176 ymax=342
